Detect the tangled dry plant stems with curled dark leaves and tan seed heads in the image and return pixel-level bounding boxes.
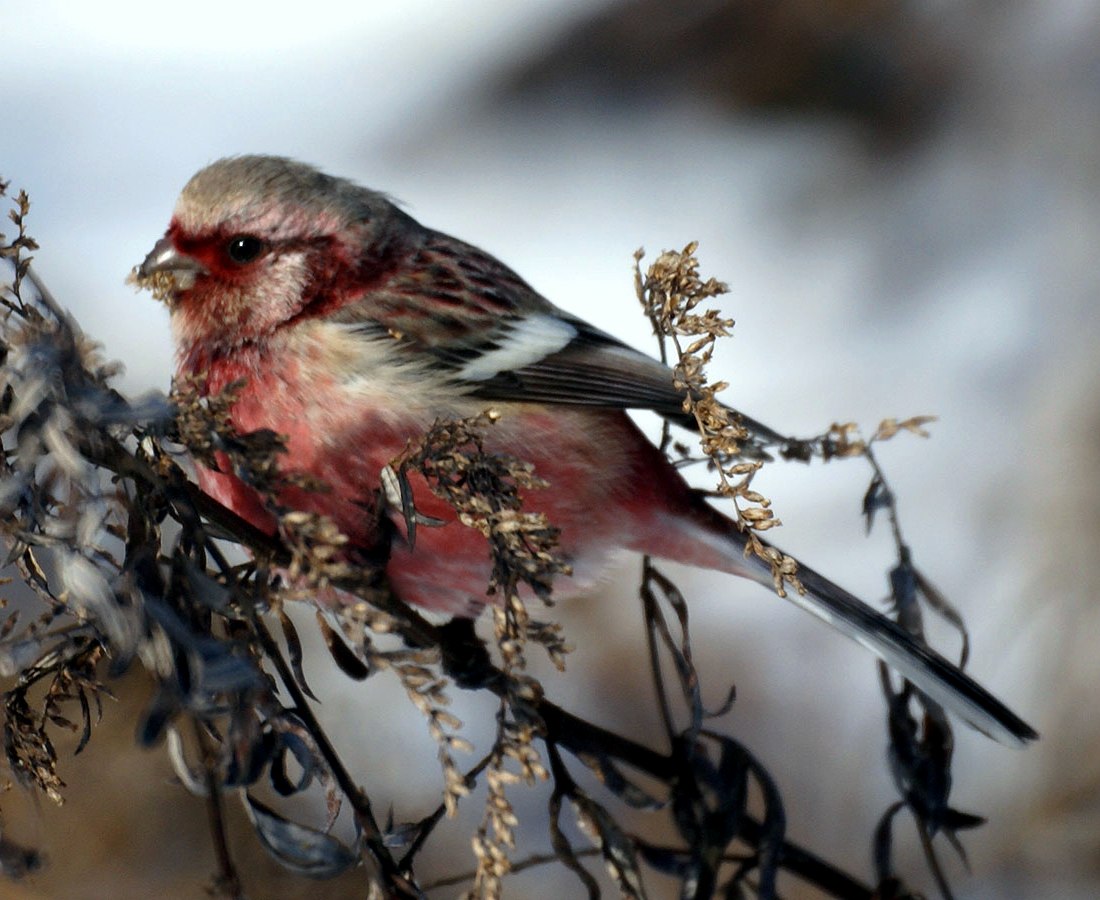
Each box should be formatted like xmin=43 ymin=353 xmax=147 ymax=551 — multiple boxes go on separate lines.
xmin=0 ymin=179 xmax=979 ymax=898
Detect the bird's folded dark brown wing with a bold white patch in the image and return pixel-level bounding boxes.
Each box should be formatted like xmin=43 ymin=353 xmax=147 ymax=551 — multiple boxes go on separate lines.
xmin=343 ymin=232 xmax=784 ymax=449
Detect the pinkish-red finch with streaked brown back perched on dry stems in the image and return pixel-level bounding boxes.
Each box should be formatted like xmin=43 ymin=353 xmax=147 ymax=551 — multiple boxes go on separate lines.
xmin=136 ymin=155 xmax=1037 ymax=746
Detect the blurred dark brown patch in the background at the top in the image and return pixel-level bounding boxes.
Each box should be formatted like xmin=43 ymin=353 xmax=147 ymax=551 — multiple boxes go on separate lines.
xmin=504 ymin=0 xmax=957 ymax=143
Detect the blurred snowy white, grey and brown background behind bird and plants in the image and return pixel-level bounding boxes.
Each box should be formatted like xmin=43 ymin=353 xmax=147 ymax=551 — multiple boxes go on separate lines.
xmin=0 ymin=0 xmax=1100 ymax=898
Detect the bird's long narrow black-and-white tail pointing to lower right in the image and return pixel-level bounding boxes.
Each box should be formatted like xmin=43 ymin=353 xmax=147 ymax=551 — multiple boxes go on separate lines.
xmin=649 ymin=503 xmax=1038 ymax=746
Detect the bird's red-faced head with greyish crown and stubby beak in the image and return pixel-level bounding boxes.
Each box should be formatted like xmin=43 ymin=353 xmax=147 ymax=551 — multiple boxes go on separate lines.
xmin=135 ymin=156 xmax=410 ymax=350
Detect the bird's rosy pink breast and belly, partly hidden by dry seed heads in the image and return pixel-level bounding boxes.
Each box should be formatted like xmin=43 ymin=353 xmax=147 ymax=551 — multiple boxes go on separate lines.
xmin=184 ymin=341 xmax=708 ymax=614
